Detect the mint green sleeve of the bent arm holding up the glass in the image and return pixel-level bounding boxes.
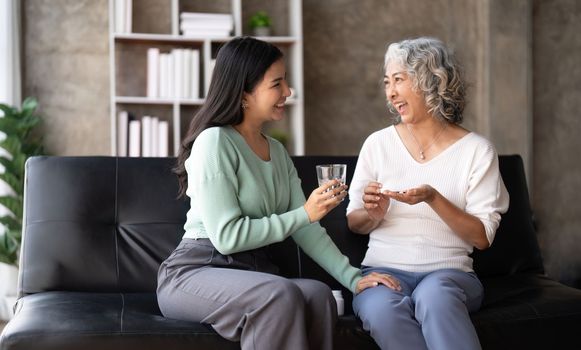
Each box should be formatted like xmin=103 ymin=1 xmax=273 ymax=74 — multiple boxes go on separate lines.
xmin=186 ymin=128 xmax=309 ymax=254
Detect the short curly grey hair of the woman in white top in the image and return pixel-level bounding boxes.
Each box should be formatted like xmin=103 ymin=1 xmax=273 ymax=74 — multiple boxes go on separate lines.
xmin=383 ymin=37 xmax=466 ymax=124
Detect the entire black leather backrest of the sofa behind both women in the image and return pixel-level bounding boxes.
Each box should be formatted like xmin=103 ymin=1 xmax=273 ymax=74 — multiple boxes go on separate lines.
xmin=18 ymin=156 xmax=542 ymax=298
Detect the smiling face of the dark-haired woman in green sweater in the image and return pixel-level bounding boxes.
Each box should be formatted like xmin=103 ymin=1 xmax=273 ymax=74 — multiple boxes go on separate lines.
xmin=244 ymin=59 xmax=291 ymax=124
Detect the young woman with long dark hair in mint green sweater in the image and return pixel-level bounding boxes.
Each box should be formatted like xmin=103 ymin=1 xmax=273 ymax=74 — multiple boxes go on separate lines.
xmin=157 ymin=37 xmax=388 ymax=350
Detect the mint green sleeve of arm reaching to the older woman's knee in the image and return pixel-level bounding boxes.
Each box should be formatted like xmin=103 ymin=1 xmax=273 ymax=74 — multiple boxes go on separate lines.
xmin=287 ymin=156 xmax=362 ymax=293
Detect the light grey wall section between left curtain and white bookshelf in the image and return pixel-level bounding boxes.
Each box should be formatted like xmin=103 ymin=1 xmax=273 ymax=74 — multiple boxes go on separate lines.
xmin=22 ymin=0 xmax=111 ymax=155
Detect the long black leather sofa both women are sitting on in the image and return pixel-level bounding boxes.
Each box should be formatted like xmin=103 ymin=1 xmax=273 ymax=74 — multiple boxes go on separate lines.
xmin=0 ymin=156 xmax=581 ymax=350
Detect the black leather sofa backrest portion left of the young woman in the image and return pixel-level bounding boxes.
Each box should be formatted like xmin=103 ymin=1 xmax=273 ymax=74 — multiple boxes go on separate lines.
xmin=18 ymin=157 xmax=188 ymax=295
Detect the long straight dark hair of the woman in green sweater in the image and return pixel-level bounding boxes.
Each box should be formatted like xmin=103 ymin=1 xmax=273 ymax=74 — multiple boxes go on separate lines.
xmin=173 ymin=37 xmax=283 ymax=197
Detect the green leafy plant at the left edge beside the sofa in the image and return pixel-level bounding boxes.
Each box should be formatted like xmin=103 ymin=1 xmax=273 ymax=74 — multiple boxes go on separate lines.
xmin=0 ymin=98 xmax=43 ymax=266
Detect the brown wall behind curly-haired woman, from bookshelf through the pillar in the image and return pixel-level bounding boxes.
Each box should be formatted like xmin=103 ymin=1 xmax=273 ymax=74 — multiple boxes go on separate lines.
xmin=303 ymin=0 xmax=532 ymax=183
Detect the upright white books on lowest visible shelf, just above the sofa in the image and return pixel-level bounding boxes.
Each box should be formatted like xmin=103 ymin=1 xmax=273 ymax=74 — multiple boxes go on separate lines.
xmin=117 ymin=111 xmax=169 ymax=157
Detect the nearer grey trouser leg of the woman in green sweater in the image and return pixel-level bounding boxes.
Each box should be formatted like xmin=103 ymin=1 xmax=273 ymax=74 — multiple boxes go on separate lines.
xmin=158 ymin=267 xmax=308 ymax=350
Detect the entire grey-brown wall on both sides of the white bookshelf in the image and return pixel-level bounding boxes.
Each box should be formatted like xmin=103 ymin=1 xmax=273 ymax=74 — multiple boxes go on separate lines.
xmin=23 ymin=0 xmax=581 ymax=287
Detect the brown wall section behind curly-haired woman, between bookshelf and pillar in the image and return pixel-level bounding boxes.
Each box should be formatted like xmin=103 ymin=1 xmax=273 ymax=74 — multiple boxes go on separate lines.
xmin=303 ymin=0 xmax=486 ymax=155
